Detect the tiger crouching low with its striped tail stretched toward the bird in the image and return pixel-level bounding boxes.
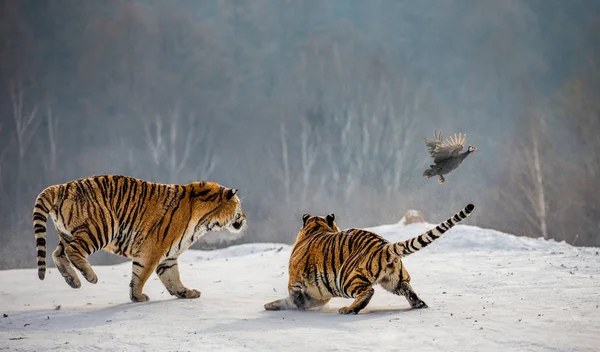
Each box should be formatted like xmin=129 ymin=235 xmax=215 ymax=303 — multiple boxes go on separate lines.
xmin=264 ymin=204 xmax=475 ymax=314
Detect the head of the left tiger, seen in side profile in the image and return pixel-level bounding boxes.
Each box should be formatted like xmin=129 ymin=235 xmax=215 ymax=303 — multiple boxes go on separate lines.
xmin=191 ymin=182 xmax=248 ymax=233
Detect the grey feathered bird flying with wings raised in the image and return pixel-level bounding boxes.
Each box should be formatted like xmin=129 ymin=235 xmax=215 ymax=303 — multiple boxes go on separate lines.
xmin=423 ymin=131 xmax=477 ymax=184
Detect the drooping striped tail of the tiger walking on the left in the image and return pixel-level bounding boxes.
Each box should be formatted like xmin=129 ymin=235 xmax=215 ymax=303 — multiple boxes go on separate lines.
xmin=33 ymin=186 xmax=58 ymax=280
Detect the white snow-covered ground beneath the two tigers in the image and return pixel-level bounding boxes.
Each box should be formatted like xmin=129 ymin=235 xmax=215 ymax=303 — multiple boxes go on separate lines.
xmin=0 ymin=220 xmax=600 ymax=352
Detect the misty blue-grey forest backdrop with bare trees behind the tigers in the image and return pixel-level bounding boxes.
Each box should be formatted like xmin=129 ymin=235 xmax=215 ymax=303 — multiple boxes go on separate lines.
xmin=0 ymin=0 xmax=600 ymax=269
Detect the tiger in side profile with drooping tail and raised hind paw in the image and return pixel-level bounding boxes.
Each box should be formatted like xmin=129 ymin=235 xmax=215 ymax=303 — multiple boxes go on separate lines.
xmin=33 ymin=175 xmax=247 ymax=302
